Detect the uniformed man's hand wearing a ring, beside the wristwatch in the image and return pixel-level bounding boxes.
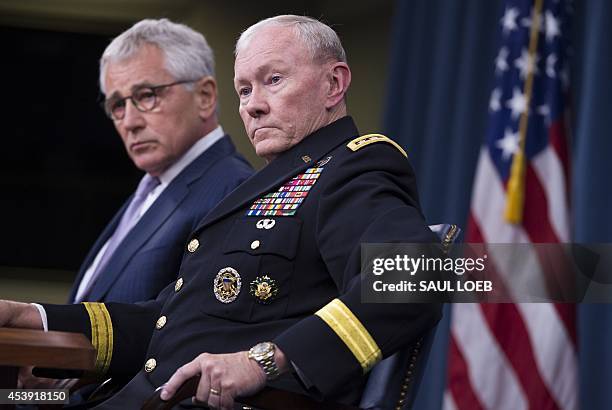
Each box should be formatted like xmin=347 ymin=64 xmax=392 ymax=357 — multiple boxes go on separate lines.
xmin=161 ymin=348 xmax=287 ymax=409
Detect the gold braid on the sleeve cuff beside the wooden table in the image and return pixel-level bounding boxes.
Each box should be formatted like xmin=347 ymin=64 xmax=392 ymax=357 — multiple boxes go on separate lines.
xmin=83 ymin=302 xmax=113 ymax=374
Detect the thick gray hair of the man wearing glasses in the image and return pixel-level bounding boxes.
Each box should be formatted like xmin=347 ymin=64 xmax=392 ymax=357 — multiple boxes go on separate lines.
xmin=100 ymin=19 xmax=215 ymax=94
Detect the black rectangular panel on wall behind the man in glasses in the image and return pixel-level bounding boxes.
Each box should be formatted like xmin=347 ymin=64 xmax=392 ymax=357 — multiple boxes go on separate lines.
xmin=0 ymin=27 xmax=140 ymax=270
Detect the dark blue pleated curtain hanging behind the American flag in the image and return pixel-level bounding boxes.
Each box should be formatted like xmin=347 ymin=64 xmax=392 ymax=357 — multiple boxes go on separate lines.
xmin=384 ymin=0 xmax=612 ymax=409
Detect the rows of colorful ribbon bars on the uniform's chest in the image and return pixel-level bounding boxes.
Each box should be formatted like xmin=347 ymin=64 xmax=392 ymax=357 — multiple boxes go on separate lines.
xmin=247 ymin=156 xmax=332 ymax=216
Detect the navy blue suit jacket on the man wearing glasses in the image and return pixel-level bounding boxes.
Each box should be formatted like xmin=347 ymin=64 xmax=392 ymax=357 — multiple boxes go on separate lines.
xmin=69 ymin=135 xmax=253 ymax=303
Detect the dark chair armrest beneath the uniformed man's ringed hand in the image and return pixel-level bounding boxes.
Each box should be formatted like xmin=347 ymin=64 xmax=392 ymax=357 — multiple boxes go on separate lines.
xmin=142 ymin=377 xmax=358 ymax=410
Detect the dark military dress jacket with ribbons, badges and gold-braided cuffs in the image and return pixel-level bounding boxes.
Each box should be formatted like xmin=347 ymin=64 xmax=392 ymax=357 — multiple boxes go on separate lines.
xmin=45 ymin=117 xmax=440 ymax=408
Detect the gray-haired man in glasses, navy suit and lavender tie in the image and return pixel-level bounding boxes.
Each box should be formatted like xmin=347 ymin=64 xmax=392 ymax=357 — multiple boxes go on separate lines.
xmin=70 ymin=19 xmax=252 ymax=302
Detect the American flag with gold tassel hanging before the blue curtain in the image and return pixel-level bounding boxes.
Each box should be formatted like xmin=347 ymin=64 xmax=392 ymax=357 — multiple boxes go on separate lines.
xmin=444 ymin=0 xmax=578 ymax=410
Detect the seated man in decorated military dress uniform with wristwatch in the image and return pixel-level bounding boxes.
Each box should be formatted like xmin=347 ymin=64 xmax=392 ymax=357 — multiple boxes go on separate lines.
xmin=0 ymin=16 xmax=440 ymax=408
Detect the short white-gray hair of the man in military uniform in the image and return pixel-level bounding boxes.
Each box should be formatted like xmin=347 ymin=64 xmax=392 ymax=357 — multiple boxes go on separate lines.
xmin=234 ymin=14 xmax=346 ymax=63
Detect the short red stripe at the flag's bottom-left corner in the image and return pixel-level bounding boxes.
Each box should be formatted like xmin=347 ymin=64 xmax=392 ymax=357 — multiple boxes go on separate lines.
xmin=448 ymin=334 xmax=484 ymax=410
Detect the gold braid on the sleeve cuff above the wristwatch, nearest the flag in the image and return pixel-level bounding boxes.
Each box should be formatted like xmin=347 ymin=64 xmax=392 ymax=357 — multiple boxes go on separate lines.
xmin=315 ymin=299 xmax=382 ymax=373
